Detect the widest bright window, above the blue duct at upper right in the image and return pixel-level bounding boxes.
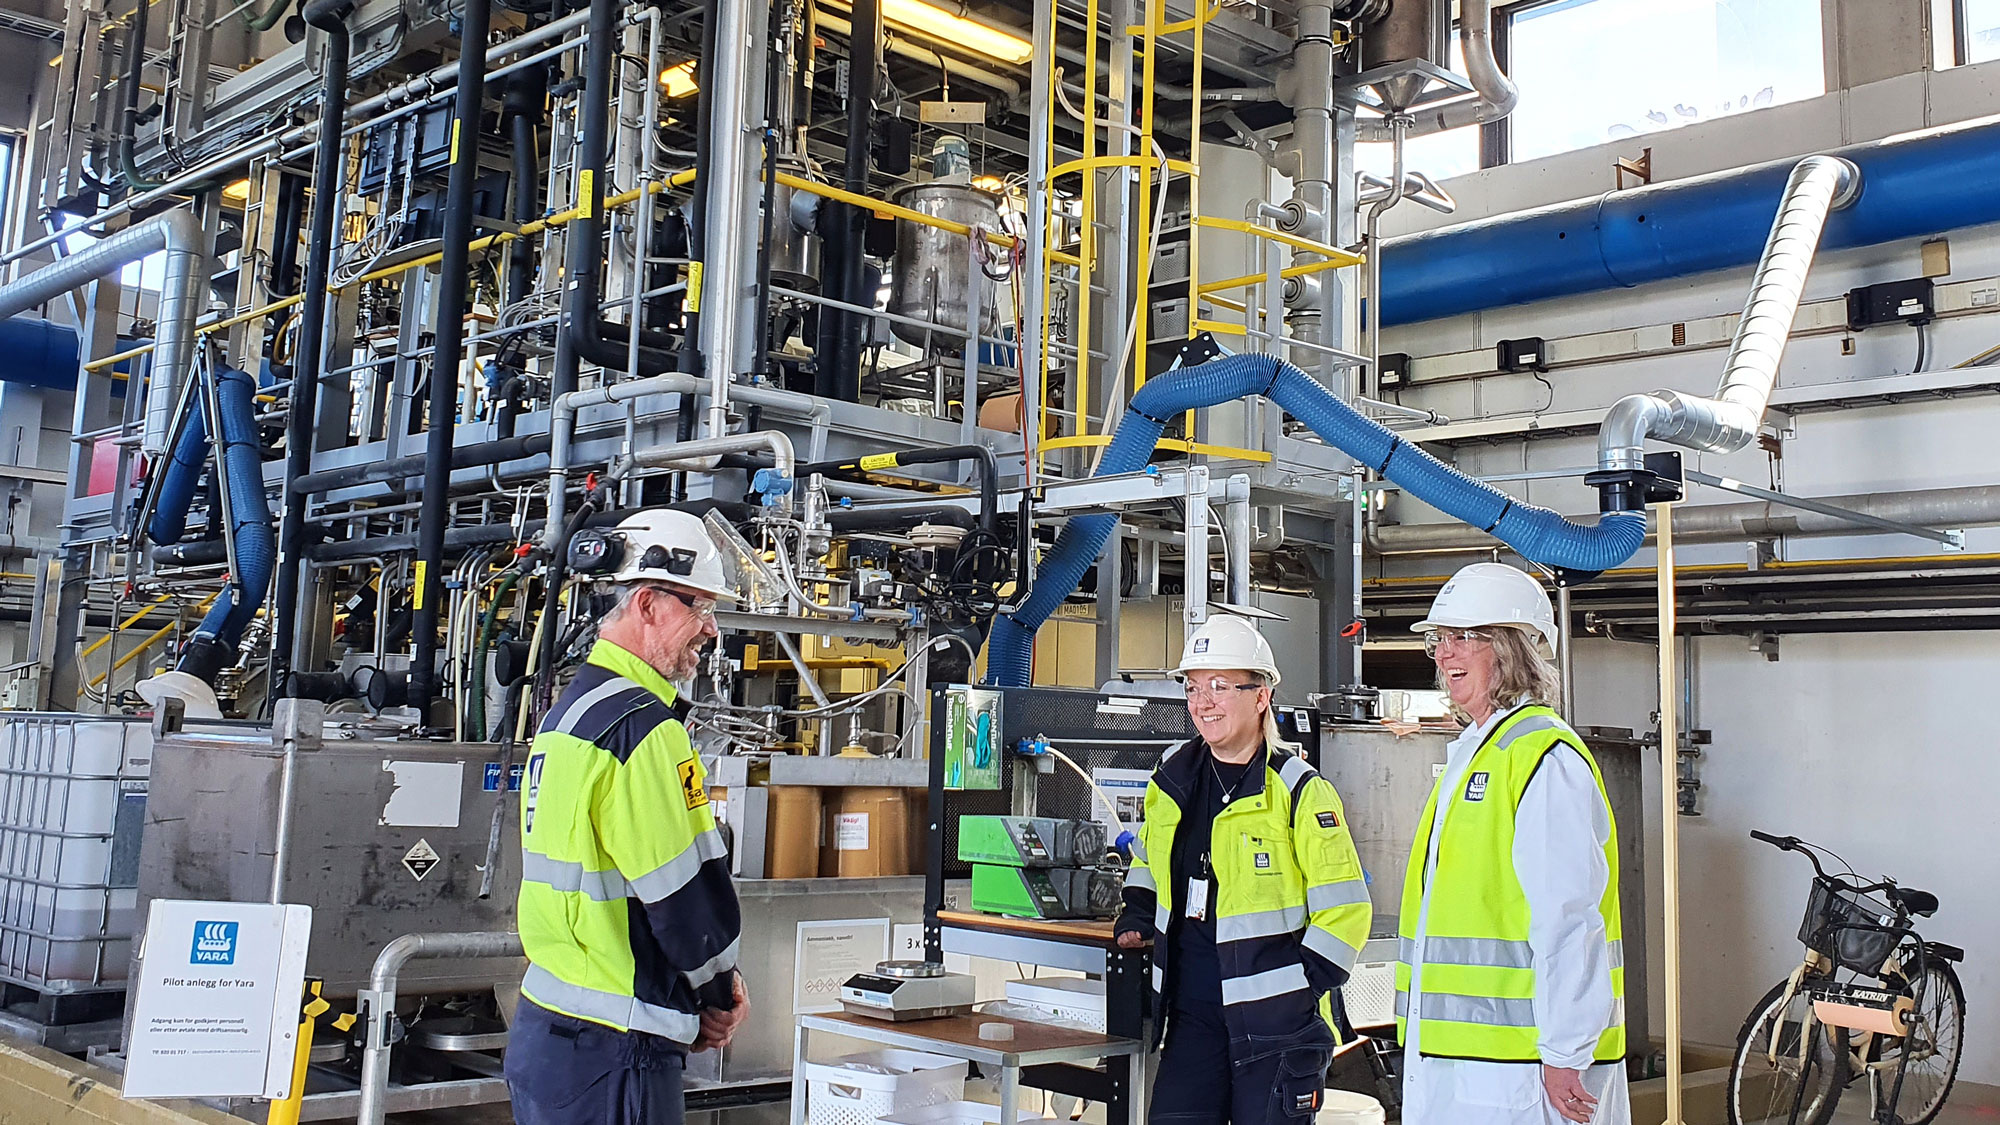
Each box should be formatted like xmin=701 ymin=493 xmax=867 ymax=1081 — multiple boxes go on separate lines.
xmin=1508 ymin=0 xmax=1824 ymax=160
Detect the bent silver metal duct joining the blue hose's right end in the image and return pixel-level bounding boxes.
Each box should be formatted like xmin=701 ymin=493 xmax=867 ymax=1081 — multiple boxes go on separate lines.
xmin=1598 ymin=156 xmax=1862 ymax=470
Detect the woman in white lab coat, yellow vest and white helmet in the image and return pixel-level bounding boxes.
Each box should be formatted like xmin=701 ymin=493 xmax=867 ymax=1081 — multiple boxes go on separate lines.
xmin=1396 ymin=563 xmax=1632 ymax=1125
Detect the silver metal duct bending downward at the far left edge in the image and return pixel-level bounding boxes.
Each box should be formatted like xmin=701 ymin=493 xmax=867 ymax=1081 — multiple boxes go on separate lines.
xmin=0 ymin=208 xmax=208 ymax=454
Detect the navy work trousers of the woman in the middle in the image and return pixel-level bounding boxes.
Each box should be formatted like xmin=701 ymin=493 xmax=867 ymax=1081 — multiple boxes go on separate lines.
xmin=1148 ymin=1005 xmax=1330 ymax=1125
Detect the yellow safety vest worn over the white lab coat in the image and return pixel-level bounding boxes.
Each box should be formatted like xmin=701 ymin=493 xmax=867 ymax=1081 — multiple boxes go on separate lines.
xmin=1396 ymin=707 xmax=1626 ymax=1063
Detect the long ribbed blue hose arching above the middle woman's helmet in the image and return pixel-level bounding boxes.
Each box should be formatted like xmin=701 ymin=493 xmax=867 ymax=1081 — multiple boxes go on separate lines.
xmin=986 ymin=354 xmax=1646 ymax=687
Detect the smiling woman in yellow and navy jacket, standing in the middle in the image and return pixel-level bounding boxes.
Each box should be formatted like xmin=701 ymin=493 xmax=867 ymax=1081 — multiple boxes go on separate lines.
xmin=1116 ymin=617 xmax=1372 ymax=1125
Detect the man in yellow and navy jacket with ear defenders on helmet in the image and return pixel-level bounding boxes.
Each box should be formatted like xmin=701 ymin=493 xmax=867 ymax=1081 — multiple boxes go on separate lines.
xmin=506 ymin=510 xmax=750 ymax=1125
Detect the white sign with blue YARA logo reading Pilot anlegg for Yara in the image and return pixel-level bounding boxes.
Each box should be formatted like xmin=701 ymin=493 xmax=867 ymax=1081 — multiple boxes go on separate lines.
xmin=124 ymin=899 xmax=312 ymax=1099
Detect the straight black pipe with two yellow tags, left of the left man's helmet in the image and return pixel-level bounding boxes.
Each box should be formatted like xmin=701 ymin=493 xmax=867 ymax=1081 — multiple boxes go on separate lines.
xmin=410 ymin=0 xmax=492 ymax=727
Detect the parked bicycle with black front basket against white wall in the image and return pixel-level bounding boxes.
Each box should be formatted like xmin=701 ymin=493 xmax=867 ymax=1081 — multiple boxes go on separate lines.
xmin=1728 ymin=831 xmax=1966 ymax=1125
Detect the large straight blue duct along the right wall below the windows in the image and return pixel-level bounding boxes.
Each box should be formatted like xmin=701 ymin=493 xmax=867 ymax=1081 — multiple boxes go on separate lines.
xmin=1382 ymin=118 xmax=2000 ymax=324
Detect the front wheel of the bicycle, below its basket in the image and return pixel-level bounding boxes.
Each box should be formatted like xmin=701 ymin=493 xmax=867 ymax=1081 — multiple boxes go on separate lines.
xmin=1728 ymin=983 xmax=1848 ymax=1125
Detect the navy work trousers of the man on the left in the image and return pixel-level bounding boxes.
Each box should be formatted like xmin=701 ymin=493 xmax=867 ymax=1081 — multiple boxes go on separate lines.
xmin=506 ymin=997 xmax=688 ymax=1125
